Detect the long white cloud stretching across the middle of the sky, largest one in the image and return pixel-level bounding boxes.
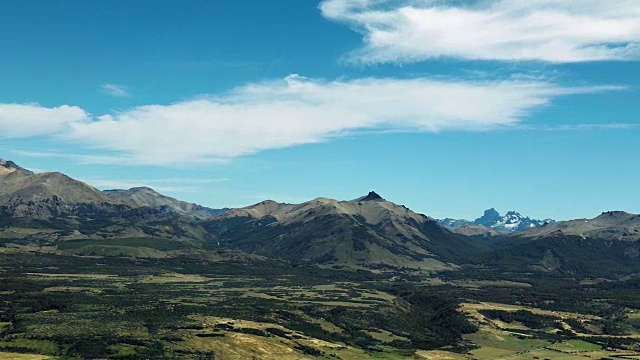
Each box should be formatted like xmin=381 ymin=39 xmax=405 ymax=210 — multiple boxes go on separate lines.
xmin=67 ymin=75 xmax=611 ymax=165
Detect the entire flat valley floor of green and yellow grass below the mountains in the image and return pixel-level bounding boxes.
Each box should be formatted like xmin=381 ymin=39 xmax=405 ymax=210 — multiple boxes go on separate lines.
xmin=0 ymin=252 xmax=640 ymax=360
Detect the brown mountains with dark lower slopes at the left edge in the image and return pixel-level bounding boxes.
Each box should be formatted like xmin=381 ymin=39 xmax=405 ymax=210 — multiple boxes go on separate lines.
xmin=0 ymin=160 xmax=220 ymax=245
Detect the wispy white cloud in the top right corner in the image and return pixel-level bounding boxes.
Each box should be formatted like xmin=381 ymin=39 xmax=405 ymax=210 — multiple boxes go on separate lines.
xmin=320 ymin=0 xmax=640 ymax=63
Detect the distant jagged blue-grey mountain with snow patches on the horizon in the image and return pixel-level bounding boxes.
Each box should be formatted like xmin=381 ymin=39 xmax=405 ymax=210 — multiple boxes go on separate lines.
xmin=438 ymin=208 xmax=555 ymax=232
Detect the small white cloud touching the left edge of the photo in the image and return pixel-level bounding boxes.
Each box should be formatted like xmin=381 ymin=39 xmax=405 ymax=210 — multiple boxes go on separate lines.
xmin=0 ymin=104 xmax=89 ymax=138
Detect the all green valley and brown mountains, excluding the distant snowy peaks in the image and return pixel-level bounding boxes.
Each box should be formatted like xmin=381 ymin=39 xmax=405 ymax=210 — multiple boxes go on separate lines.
xmin=0 ymin=162 xmax=640 ymax=360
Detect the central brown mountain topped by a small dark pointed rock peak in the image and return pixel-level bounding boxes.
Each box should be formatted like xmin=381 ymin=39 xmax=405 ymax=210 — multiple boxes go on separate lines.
xmin=205 ymin=194 xmax=476 ymax=269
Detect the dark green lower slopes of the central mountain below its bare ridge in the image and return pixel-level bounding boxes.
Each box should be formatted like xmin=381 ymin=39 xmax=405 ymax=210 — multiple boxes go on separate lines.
xmin=203 ymin=215 xmax=484 ymax=267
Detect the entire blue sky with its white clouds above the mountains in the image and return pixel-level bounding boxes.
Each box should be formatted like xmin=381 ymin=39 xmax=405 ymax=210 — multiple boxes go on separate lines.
xmin=0 ymin=0 xmax=640 ymax=219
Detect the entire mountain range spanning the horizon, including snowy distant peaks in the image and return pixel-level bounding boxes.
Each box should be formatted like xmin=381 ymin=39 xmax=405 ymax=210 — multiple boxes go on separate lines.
xmin=0 ymin=160 xmax=640 ymax=274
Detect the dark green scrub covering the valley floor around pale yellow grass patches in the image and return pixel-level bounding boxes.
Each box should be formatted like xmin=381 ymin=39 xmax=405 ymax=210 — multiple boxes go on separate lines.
xmin=0 ymin=239 xmax=640 ymax=359
